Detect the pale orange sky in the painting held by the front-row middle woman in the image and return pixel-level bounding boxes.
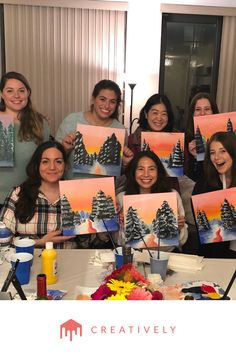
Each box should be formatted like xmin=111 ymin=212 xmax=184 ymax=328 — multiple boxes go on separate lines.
xmin=124 ymin=192 xmax=177 ymax=224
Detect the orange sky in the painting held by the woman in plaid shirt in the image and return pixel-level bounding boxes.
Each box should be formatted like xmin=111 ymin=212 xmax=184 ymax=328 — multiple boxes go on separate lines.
xmin=59 ymin=177 xmax=115 ymax=211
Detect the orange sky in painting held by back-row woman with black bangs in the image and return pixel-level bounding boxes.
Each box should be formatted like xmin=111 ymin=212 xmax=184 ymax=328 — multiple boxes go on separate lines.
xmin=141 ymin=132 xmax=184 ymax=157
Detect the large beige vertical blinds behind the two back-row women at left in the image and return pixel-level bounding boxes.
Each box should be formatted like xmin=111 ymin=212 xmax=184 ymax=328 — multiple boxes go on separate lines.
xmin=4 ymin=5 xmax=126 ymax=135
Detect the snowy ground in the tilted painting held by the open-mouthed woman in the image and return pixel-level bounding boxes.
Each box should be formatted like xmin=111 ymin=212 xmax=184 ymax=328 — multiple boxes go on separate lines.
xmin=199 ymin=219 xmax=236 ymax=243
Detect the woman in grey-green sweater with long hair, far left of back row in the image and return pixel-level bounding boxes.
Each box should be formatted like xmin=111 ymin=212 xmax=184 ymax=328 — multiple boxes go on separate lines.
xmin=0 ymin=71 xmax=49 ymax=204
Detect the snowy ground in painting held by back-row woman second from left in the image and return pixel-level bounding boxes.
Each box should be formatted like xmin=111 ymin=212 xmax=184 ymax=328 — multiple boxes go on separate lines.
xmin=73 ymin=161 xmax=121 ymax=176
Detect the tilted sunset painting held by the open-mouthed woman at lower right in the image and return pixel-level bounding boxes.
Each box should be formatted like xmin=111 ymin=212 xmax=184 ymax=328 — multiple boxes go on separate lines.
xmin=192 ymin=188 xmax=236 ymax=243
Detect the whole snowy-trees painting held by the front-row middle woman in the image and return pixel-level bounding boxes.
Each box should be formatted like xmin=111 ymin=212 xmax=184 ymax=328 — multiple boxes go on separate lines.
xmin=123 ymin=192 xmax=179 ymax=248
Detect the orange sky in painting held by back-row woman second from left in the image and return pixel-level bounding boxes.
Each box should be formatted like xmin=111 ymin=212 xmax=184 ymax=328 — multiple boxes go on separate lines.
xmin=76 ymin=124 xmax=125 ymax=154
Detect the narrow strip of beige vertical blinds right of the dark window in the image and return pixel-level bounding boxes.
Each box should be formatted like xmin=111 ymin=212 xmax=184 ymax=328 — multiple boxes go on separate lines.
xmin=217 ymin=16 xmax=236 ymax=112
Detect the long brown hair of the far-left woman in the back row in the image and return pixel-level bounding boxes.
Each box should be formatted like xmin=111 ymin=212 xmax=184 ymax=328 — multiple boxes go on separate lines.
xmin=0 ymin=71 xmax=46 ymax=144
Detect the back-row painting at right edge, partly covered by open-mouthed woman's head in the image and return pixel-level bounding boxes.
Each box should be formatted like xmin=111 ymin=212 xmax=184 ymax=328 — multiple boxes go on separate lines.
xmin=194 ymin=112 xmax=236 ymax=161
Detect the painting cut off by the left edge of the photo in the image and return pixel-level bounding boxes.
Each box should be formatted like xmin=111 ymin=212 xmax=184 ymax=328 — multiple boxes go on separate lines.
xmin=0 ymin=115 xmax=14 ymax=167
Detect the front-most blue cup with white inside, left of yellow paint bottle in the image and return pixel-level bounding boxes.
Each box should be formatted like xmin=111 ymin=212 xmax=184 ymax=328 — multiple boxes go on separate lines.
xmin=11 ymin=253 xmax=33 ymax=285
